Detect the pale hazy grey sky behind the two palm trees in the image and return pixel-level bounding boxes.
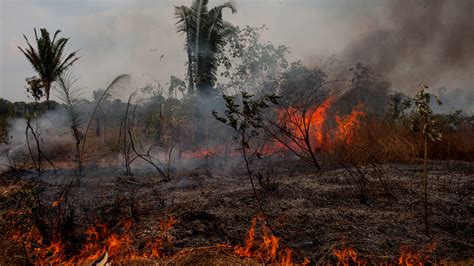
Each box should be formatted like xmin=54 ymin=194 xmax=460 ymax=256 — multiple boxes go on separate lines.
xmin=0 ymin=0 xmax=474 ymax=101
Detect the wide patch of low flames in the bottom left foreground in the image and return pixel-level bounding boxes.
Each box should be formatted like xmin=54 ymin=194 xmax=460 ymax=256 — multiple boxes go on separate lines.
xmin=27 ymin=217 xmax=176 ymax=265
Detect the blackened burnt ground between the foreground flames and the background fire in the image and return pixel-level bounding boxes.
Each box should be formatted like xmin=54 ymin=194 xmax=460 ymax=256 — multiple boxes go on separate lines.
xmin=0 ymin=160 xmax=474 ymax=261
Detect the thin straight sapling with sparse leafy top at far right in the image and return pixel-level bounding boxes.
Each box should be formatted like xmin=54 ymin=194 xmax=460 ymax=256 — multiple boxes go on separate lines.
xmin=410 ymin=85 xmax=443 ymax=235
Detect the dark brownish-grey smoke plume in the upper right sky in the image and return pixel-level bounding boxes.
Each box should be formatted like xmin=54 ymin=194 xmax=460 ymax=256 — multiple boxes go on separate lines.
xmin=343 ymin=0 xmax=474 ymax=89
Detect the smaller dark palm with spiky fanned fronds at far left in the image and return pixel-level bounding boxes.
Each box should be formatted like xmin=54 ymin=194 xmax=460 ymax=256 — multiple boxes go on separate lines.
xmin=18 ymin=29 xmax=79 ymax=109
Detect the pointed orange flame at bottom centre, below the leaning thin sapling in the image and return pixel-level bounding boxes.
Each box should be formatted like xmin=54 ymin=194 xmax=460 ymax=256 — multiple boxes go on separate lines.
xmin=234 ymin=216 xmax=293 ymax=265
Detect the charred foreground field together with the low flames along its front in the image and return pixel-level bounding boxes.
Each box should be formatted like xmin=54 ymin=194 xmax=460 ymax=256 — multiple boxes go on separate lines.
xmin=1 ymin=162 xmax=474 ymax=265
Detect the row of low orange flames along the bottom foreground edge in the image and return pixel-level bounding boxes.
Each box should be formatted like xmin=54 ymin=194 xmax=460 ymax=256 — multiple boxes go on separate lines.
xmin=5 ymin=208 xmax=446 ymax=266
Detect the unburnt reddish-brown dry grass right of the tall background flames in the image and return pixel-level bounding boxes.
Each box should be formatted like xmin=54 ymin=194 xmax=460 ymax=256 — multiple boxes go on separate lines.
xmin=334 ymin=118 xmax=474 ymax=164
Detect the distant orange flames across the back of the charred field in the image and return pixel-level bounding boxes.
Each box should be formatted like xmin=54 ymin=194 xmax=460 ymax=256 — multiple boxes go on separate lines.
xmin=182 ymin=96 xmax=365 ymax=159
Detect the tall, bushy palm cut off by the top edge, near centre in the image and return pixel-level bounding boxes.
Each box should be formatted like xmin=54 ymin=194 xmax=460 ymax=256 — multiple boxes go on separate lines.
xmin=175 ymin=0 xmax=237 ymax=95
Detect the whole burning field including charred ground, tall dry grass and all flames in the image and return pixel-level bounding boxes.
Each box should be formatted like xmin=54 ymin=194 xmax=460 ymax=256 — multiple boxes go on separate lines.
xmin=0 ymin=93 xmax=474 ymax=265
